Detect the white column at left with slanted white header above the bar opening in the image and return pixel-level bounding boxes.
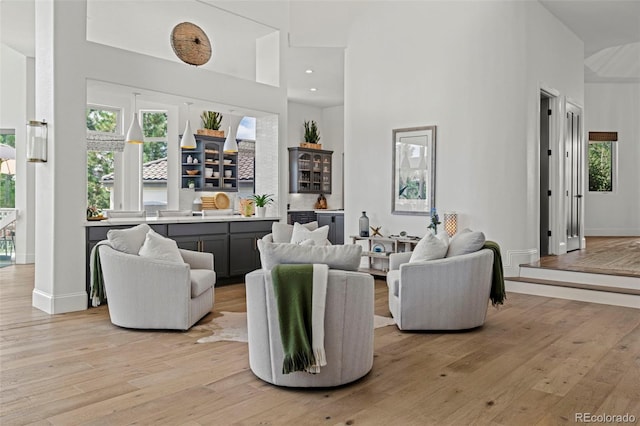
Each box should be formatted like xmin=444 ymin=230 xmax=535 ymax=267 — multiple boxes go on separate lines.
xmin=33 ymin=0 xmax=287 ymax=313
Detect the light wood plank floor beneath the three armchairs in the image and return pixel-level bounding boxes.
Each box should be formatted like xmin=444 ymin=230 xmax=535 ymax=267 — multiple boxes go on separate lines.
xmin=0 ymin=265 xmax=640 ymax=426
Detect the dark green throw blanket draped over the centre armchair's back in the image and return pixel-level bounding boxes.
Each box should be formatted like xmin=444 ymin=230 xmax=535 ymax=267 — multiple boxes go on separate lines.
xmin=271 ymin=265 xmax=315 ymax=374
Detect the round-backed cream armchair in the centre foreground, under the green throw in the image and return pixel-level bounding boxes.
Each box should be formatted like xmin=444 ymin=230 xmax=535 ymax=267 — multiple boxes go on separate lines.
xmin=246 ymin=268 xmax=374 ymax=387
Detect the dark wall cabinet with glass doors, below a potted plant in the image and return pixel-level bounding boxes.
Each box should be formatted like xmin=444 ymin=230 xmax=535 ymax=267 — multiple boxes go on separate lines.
xmin=289 ymin=147 xmax=333 ymax=194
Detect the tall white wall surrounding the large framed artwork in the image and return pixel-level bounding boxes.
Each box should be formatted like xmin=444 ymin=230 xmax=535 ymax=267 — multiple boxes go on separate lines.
xmin=344 ymin=2 xmax=583 ymax=275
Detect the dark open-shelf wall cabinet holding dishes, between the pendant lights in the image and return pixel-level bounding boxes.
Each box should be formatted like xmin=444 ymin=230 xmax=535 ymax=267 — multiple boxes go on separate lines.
xmin=180 ymin=135 xmax=238 ymax=192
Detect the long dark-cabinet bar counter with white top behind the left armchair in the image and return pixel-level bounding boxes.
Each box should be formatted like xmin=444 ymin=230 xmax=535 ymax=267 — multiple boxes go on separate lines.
xmin=85 ymin=215 xmax=280 ymax=300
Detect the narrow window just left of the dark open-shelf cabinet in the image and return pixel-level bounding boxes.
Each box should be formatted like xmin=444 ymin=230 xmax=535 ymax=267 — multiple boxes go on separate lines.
xmin=140 ymin=109 xmax=169 ymax=215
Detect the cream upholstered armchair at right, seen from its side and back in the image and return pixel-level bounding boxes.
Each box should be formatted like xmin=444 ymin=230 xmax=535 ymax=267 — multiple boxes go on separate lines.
xmin=387 ymin=249 xmax=493 ymax=330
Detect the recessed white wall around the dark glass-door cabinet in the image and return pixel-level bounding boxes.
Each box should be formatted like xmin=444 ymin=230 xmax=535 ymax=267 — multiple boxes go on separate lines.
xmin=281 ymin=102 xmax=344 ymax=210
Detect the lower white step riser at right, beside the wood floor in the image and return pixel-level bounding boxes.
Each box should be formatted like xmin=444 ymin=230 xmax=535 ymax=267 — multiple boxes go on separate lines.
xmin=505 ymin=279 xmax=640 ymax=309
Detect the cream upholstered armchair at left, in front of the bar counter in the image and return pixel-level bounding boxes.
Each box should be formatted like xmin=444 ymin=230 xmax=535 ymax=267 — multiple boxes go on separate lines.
xmin=96 ymin=241 xmax=216 ymax=330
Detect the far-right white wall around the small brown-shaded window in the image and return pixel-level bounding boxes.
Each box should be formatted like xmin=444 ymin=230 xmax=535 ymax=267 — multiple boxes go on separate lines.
xmin=585 ymin=83 xmax=640 ymax=236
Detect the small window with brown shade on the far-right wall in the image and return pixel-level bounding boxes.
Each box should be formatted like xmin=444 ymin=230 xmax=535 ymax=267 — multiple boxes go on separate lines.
xmin=587 ymin=132 xmax=618 ymax=193
